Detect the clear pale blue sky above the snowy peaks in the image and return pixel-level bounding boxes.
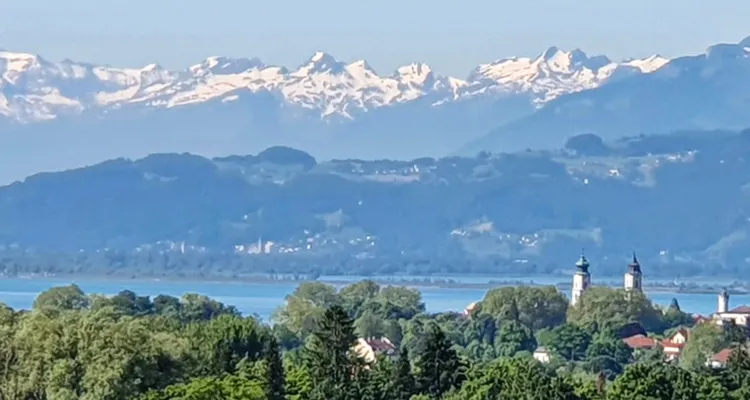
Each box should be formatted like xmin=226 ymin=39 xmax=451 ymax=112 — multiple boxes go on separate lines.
xmin=0 ymin=0 xmax=750 ymax=77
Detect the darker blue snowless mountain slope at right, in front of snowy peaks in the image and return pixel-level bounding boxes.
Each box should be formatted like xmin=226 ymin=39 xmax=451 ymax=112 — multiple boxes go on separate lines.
xmin=462 ymin=37 xmax=750 ymax=154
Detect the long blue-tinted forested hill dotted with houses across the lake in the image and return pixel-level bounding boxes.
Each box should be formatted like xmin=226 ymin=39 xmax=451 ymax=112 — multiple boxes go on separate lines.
xmin=0 ymin=131 xmax=750 ymax=275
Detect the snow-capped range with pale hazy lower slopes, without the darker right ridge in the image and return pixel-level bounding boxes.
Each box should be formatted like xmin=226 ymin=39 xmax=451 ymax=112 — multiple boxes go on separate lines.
xmin=0 ymin=43 xmax=667 ymax=181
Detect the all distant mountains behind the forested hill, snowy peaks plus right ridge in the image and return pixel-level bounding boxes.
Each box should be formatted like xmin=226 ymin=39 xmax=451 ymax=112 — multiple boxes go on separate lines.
xmin=0 ymin=37 xmax=750 ymax=184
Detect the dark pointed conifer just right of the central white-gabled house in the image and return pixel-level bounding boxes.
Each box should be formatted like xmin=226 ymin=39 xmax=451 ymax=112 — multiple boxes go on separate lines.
xmin=415 ymin=323 xmax=465 ymax=399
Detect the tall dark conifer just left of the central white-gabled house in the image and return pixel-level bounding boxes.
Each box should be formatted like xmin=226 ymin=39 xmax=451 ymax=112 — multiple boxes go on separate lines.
xmin=305 ymin=305 xmax=361 ymax=400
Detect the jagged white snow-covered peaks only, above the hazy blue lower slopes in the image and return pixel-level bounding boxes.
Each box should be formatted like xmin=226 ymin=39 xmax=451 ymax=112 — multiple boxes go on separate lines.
xmin=0 ymin=47 xmax=669 ymax=123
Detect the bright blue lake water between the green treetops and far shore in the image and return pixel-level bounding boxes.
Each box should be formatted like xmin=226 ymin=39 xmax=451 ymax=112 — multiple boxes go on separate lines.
xmin=0 ymin=278 xmax=750 ymax=321
